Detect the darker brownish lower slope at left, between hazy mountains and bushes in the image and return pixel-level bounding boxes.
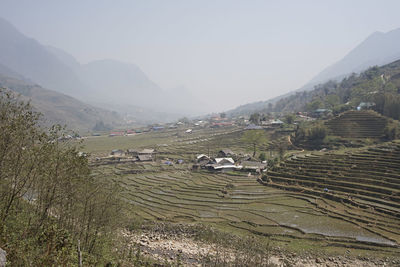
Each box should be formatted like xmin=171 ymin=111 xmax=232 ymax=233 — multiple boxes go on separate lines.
xmin=0 ymin=73 xmax=122 ymax=132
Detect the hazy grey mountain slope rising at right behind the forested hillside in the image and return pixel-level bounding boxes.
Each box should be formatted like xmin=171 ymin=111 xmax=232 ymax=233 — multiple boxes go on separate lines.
xmin=227 ymin=28 xmax=400 ymax=115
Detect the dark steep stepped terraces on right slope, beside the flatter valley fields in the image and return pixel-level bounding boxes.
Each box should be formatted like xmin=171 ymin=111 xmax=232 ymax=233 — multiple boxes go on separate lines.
xmin=266 ymin=142 xmax=400 ymax=249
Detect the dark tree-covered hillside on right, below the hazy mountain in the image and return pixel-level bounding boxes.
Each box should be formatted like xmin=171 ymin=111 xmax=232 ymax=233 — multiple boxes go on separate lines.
xmin=270 ymin=61 xmax=400 ymax=119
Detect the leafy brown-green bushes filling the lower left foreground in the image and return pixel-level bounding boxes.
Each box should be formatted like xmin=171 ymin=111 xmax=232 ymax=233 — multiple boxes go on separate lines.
xmin=0 ymin=89 xmax=122 ymax=266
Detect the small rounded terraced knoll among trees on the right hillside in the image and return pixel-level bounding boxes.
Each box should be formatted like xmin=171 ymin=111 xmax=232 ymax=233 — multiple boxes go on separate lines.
xmin=326 ymin=110 xmax=387 ymax=138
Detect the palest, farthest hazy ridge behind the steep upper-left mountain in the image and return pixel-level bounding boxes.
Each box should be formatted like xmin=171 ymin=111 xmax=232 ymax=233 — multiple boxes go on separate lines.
xmin=48 ymin=47 xmax=206 ymax=116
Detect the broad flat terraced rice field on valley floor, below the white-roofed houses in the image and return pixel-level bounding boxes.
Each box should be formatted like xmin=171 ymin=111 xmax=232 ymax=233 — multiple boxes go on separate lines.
xmin=93 ymin=160 xmax=394 ymax=254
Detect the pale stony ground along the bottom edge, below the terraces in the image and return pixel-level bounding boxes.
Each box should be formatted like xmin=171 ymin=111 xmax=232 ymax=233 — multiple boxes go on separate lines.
xmin=123 ymin=231 xmax=400 ymax=267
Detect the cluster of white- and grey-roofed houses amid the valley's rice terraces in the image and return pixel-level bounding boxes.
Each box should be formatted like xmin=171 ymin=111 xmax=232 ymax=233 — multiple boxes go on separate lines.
xmin=193 ymin=149 xmax=267 ymax=173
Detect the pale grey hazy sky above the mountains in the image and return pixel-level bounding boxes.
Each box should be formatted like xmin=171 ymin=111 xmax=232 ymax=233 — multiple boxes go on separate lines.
xmin=0 ymin=0 xmax=400 ymax=111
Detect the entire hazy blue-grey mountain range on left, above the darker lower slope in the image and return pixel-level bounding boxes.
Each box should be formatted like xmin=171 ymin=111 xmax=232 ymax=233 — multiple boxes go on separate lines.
xmin=0 ymin=18 xmax=205 ymax=118
